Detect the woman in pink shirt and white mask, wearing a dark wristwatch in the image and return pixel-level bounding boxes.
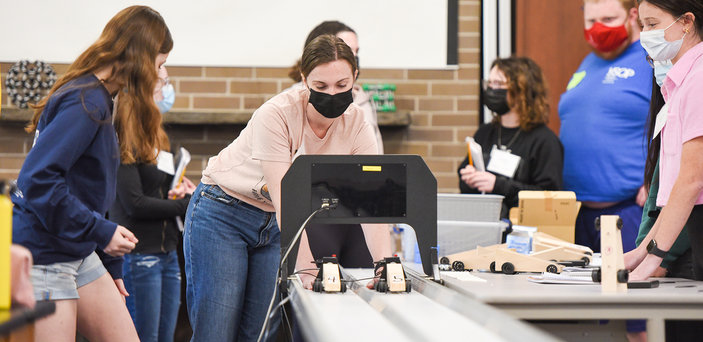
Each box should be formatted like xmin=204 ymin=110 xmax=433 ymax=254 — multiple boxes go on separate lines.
xmin=625 ymin=0 xmax=703 ymax=280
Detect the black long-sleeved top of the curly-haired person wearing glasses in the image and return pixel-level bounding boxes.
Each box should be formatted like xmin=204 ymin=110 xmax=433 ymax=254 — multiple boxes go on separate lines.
xmin=459 ymin=123 xmax=564 ymax=218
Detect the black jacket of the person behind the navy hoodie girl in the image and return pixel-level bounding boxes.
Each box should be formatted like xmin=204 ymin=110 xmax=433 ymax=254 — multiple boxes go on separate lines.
xmin=109 ymin=163 xmax=190 ymax=253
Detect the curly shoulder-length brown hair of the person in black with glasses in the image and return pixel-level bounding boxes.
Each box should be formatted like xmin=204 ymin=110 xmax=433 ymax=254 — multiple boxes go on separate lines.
xmin=491 ymin=57 xmax=549 ymax=131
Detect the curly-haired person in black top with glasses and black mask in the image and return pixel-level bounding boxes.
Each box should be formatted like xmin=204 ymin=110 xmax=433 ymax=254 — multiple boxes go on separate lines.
xmin=459 ymin=57 xmax=564 ymax=218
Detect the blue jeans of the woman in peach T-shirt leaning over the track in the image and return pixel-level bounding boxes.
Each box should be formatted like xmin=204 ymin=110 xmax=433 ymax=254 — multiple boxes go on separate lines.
xmin=183 ymin=183 xmax=281 ymax=342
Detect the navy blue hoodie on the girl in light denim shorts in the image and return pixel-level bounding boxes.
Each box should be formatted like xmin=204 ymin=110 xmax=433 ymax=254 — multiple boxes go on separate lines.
xmin=12 ymin=74 xmax=122 ymax=278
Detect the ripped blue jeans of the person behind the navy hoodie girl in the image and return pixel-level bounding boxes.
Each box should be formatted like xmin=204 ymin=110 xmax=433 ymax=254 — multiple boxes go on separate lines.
xmin=123 ymin=251 xmax=181 ymax=342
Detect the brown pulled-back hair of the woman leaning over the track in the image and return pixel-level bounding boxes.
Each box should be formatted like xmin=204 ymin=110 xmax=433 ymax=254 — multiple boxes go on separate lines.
xmin=300 ymin=34 xmax=356 ymax=78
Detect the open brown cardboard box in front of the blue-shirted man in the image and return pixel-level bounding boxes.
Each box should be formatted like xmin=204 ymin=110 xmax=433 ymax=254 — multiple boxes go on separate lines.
xmin=511 ymin=191 xmax=581 ymax=243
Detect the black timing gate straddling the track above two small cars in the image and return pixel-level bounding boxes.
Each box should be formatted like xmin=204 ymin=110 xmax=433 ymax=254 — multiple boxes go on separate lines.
xmin=281 ymin=155 xmax=437 ymax=291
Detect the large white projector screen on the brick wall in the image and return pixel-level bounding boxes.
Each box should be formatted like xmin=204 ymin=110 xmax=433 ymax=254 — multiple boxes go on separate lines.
xmin=0 ymin=0 xmax=448 ymax=69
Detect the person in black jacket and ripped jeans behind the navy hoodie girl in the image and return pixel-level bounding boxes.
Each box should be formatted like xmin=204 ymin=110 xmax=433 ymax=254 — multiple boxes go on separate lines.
xmin=109 ymin=66 xmax=195 ymax=341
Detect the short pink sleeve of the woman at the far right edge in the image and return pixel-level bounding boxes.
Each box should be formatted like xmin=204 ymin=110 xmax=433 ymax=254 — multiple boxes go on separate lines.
xmin=677 ymin=71 xmax=703 ymax=143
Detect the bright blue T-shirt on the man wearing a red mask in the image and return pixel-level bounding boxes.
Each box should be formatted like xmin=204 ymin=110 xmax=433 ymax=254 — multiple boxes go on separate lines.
xmin=559 ymin=41 xmax=653 ymax=202
